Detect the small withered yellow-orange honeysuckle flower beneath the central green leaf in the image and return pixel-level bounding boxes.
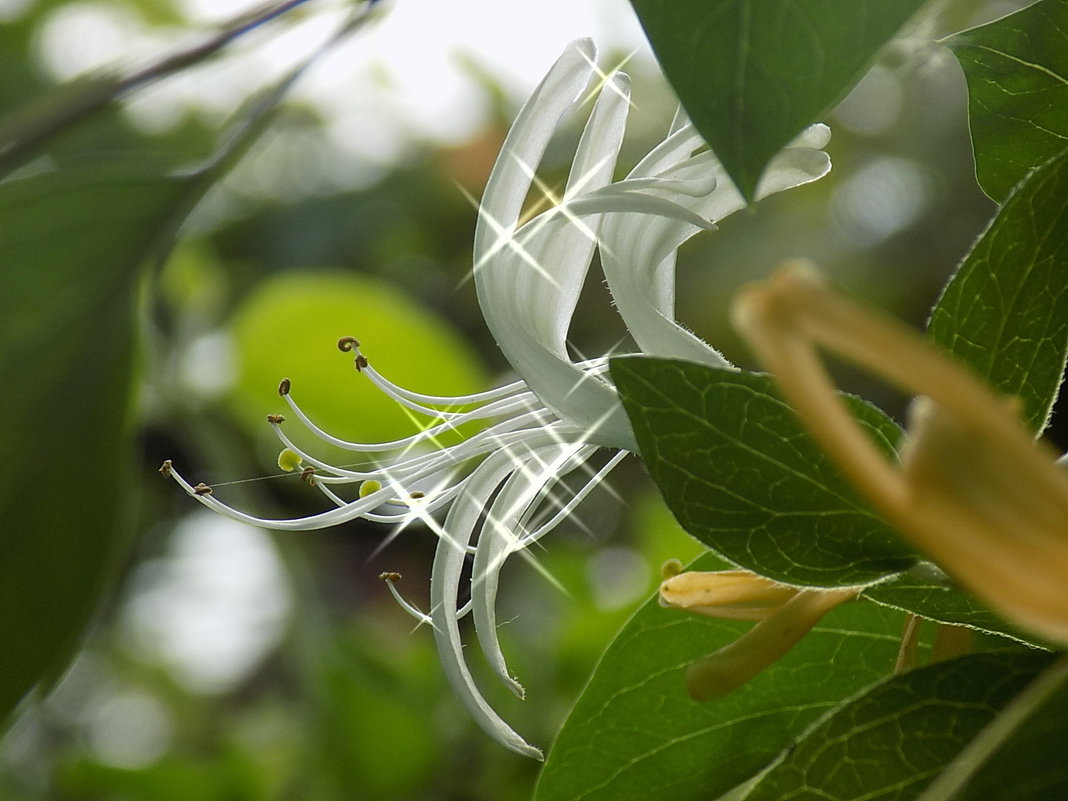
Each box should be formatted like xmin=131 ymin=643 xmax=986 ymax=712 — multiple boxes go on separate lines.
xmin=659 ymin=561 xmax=859 ymax=701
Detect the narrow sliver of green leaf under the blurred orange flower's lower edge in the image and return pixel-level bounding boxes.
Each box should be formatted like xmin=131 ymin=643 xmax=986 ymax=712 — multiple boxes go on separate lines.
xmin=864 ymin=563 xmax=1045 ymax=647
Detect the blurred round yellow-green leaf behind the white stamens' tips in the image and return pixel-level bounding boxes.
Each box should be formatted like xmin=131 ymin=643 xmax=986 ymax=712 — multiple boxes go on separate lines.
xmin=233 ymin=270 xmax=486 ymax=452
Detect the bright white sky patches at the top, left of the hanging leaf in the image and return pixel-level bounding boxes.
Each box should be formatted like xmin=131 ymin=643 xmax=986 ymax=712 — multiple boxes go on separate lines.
xmin=33 ymin=0 xmax=651 ymax=184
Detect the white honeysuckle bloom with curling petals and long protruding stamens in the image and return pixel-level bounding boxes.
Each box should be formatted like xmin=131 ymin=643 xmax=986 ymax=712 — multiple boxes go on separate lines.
xmin=162 ymin=40 xmax=830 ymax=757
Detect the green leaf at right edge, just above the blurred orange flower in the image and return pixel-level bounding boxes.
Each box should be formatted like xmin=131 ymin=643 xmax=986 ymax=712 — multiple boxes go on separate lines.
xmin=928 ymin=144 xmax=1068 ymax=431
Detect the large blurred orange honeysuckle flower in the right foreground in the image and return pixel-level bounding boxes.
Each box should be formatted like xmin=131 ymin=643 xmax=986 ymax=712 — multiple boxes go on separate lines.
xmin=733 ymin=263 xmax=1068 ymax=645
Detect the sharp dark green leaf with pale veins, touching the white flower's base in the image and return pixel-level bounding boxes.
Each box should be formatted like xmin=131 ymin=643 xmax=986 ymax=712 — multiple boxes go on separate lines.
xmin=612 ymin=358 xmax=915 ymax=586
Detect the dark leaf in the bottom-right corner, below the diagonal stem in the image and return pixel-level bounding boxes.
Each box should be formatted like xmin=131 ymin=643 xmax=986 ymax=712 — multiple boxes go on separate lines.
xmin=921 ymin=658 xmax=1068 ymax=801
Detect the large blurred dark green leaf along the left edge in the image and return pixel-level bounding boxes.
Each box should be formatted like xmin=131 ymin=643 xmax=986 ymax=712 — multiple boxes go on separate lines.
xmin=0 ymin=163 xmax=201 ymax=719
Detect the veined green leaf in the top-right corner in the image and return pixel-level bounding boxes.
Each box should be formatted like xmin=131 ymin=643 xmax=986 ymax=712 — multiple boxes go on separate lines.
xmin=946 ymin=0 xmax=1068 ymax=202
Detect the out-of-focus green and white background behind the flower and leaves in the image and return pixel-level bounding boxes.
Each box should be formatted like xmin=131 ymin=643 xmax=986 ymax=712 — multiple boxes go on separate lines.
xmin=0 ymin=0 xmax=1038 ymax=801
